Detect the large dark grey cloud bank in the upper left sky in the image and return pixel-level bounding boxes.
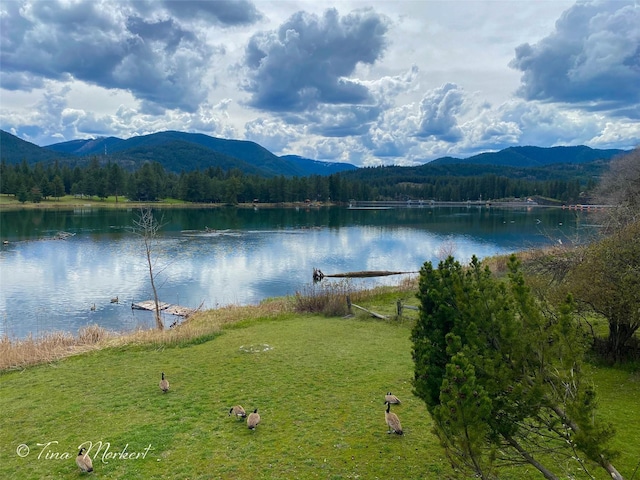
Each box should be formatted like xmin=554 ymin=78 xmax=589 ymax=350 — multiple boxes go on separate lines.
xmin=0 ymin=0 xmax=239 ymax=112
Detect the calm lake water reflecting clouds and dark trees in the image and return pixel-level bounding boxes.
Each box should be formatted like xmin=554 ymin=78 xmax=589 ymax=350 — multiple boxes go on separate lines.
xmin=0 ymin=207 xmax=590 ymax=338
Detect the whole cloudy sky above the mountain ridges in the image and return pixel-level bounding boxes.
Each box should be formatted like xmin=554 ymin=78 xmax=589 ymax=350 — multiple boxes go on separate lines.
xmin=0 ymin=0 xmax=640 ymax=166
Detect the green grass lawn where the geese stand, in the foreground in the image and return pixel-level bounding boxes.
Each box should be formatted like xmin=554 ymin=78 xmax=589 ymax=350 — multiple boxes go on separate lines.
xmin=0 ymin=314 xmax=640 ymax=479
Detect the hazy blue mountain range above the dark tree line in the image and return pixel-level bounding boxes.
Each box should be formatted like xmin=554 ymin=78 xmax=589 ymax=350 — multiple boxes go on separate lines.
xmin=0 ymin=130 xmax=625 ymax=177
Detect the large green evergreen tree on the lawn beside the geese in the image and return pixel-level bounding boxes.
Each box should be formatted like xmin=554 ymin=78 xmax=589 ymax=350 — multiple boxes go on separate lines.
xmin=412 ymin=257 xmax=622 ymax=479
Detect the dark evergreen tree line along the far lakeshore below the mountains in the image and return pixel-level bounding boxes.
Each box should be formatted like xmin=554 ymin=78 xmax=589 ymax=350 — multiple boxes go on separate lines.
xmin=0 ymin=157 xmax=595 ymax=204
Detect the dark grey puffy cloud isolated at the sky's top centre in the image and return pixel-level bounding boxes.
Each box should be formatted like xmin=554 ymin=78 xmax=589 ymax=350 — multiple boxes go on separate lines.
xmin=242 ymin=9 xmax=389 ymax=112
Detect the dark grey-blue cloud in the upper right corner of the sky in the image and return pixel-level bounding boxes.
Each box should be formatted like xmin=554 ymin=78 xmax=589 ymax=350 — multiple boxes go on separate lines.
xmin=510 ymin=0 xmax=640 ymax=119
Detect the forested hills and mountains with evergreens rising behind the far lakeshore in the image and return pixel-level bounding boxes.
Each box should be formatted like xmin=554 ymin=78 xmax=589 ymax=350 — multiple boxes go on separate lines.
xmin=0 ymin=131 xmax=632 ymax=204
